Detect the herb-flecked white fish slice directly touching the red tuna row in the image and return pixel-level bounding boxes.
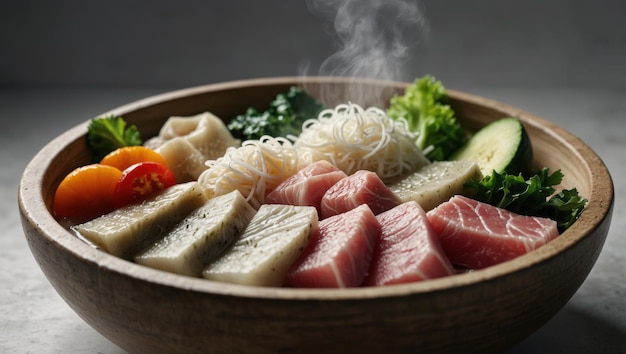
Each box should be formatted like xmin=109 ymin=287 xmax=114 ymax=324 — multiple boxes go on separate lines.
xmin=202 ymin=204 xmax=318 ymax=286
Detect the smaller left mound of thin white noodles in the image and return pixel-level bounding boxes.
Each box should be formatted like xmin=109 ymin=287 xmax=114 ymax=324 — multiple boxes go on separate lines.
xmin=198 ymin=136 xmax=298 ymax=209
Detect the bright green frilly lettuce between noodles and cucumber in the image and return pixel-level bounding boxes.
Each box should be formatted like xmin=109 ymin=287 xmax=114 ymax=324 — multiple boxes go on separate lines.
xmin=387 ymin=75 xmax=465 ymax=161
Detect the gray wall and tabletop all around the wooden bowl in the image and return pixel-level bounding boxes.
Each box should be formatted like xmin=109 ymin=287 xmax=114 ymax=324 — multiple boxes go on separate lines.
xmin=0 ymin=0 xmax=626 ymax=353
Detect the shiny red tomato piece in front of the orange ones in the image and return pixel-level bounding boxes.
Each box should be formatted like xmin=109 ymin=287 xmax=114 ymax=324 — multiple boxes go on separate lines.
xmin=115 ymin=161 xmax=176 ymax=208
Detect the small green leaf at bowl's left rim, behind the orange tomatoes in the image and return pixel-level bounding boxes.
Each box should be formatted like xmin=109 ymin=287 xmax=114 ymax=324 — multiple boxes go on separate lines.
xmin=87 ymin=116 xmax=142 ymax=161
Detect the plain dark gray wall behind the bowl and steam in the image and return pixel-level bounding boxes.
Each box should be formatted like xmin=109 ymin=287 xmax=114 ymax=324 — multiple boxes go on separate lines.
xmin=0 ymin=0 xmax=626 ymax=89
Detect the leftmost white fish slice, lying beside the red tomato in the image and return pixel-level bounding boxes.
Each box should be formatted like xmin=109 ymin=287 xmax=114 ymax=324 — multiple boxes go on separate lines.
xmin=72 ymin=182 xmax=206 ymax=259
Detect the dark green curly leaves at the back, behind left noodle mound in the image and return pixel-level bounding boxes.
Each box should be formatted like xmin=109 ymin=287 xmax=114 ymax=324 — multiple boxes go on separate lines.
xmin=228 ymin=86 xmax=324 ymax=140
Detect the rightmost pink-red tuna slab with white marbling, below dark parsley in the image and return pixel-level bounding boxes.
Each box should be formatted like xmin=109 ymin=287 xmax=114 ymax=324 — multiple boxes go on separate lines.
xmin=426 ymin=195 xmax=558 ymax=269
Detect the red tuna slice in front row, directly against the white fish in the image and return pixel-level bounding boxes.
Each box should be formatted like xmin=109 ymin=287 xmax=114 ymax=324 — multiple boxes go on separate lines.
xmin=287 ymin=204 xmax=380 ymax=288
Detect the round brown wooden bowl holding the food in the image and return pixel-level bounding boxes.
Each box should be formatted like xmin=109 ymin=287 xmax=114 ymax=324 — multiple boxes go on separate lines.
xmin=19 ymin=78 xmax=614 ymax=353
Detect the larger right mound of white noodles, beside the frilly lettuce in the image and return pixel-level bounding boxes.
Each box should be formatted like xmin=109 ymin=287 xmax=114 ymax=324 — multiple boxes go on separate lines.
xmin=294 ymin=103 xmax=429 ymax=182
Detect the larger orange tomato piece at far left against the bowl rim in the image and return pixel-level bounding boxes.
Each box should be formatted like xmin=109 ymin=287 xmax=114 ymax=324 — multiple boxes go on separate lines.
xmin=54 ymin=164 xmax=122 ymax=222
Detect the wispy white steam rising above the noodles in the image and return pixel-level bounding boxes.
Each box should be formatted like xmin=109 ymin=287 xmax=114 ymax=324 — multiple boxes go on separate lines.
xmin=300 ymin=0 xmax=427 ymax=105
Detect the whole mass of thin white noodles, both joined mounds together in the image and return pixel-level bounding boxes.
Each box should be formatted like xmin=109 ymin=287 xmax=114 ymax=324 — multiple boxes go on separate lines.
xmin=198 ymin=103 xmax=429 ymax=209
